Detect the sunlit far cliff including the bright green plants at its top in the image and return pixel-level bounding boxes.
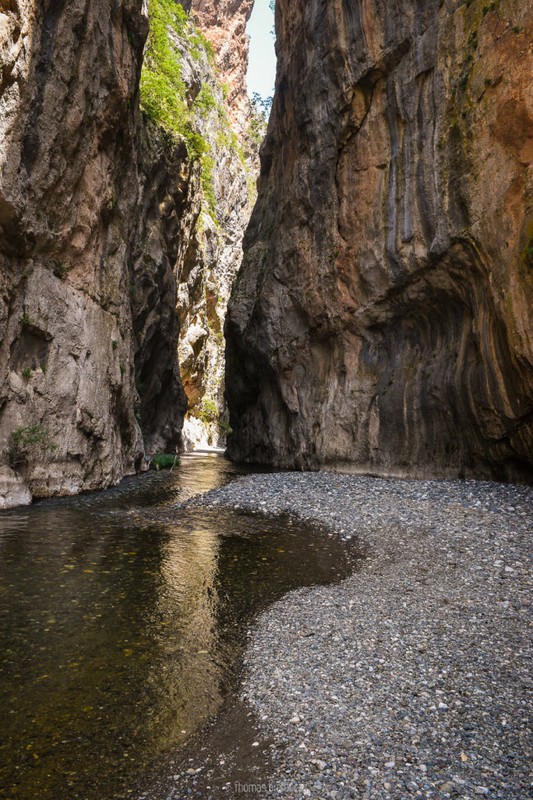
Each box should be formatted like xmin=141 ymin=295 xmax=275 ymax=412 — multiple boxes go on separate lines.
xmin=140 ymin=0 xmax=257 ymax=448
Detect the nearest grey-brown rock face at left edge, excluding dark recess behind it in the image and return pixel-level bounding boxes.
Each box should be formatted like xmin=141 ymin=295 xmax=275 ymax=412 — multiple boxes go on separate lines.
xmin=0 ymin=0 xmax=147 ymax=504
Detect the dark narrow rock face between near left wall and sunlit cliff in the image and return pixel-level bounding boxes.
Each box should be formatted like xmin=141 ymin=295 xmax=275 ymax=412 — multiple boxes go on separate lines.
xmin=130 ymin=130 xmax=193 ymax=454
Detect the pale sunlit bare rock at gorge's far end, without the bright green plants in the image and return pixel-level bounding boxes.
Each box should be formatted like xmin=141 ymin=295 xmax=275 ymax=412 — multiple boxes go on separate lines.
xmin=166 ymin=0 xmax=258 ymax=449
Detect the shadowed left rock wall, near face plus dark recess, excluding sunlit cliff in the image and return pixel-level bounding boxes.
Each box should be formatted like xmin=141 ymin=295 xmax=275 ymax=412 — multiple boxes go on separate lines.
xmin=0 ymin=0 xmax=195 ymax=505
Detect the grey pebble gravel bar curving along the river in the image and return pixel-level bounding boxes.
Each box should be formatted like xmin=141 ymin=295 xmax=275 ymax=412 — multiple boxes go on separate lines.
xmin=186 ymin=472 xmax=533 ymax=800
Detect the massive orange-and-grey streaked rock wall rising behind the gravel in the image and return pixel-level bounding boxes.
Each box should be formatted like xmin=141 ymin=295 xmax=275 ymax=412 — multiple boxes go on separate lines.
xmin=226 ymin=0 xmax=533 ymax=479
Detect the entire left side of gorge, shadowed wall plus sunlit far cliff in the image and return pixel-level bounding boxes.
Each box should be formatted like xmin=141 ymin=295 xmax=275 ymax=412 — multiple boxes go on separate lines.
xmin=0 ymin=0 xmax=254 ymax=507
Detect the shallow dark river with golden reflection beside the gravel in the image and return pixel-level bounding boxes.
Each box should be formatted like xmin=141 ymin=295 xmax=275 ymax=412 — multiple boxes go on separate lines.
xmin=0 ymin=455 xmax=358 ymax=800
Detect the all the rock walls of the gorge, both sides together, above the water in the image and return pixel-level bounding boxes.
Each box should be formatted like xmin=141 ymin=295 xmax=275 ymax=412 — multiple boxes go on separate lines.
xmin=0 ymin=0 xmax=533 ymax=507
